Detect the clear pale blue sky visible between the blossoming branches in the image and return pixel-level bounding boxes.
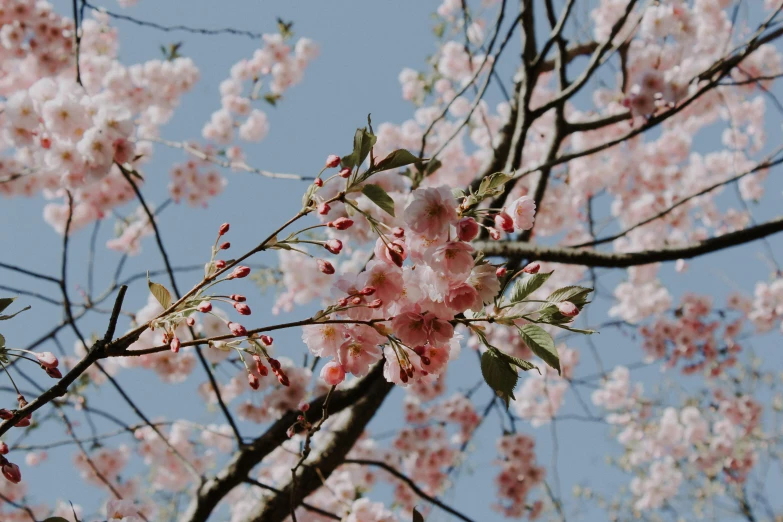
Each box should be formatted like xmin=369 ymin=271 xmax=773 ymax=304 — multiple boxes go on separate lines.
xmin=0 ymin=0 xmax=783 ymax=521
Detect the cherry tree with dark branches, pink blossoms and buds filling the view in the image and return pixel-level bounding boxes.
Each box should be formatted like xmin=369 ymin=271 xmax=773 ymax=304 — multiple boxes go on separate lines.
xmin=0 ymin=0 xmax=783 ymax=522
